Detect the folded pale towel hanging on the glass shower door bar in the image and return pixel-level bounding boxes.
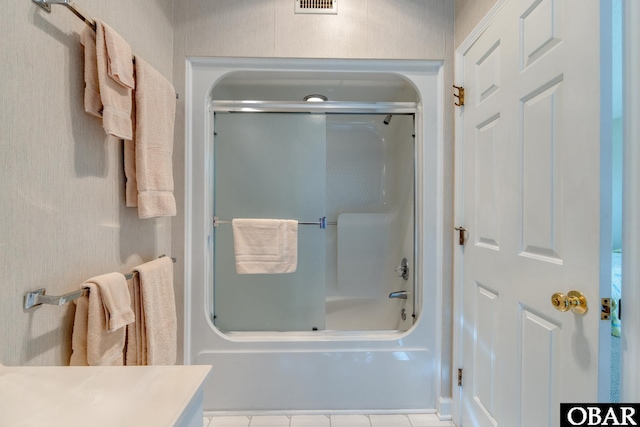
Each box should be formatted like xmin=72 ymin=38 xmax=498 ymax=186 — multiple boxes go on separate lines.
xmin=231 ymin=218 xmax=298 ymax=274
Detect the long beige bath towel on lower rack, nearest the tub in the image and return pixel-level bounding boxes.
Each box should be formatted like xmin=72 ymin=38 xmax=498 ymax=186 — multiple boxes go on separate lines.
xmin=126 ymin=257 xmax=178 ymax=365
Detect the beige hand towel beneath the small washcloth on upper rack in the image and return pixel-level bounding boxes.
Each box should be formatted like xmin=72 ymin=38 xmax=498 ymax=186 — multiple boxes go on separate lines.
xmin=96 ymin=20 xmax=133 ymax=140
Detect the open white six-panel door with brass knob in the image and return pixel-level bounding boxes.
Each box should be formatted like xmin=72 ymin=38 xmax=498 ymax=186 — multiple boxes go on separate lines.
xmin=458 ymin=0 xmax=608 ymax=427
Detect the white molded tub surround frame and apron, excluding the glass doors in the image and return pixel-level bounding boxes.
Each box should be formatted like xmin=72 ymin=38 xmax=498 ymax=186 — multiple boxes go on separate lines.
xmin=184 ymin=58 xmax=451 ymax=419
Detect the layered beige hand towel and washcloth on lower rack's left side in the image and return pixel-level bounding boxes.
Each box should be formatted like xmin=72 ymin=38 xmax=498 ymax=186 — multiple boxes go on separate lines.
xmin=70 ymin=273 xmax=133 ymax=366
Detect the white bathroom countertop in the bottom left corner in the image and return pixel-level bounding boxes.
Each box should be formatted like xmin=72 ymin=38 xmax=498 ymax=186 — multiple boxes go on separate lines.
xmin=0 ymin=366 xmax=211 ymax=427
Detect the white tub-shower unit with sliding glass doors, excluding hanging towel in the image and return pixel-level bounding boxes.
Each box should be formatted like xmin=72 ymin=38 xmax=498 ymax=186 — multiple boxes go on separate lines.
xmin=184 ymin=58 xmax=449 ymax=416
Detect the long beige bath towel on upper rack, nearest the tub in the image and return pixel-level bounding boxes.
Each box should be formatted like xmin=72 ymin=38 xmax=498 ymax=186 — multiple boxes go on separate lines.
xmin=135 ymin=56 xmax=176 ymax=218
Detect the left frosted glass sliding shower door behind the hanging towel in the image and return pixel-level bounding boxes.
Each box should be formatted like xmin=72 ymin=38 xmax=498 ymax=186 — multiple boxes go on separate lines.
xmin=213 ymin=112 xmax=326 ymax=331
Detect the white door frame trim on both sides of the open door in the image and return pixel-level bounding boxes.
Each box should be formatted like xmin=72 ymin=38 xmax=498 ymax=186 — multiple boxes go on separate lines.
xmin=451 ymin=0 xmax=640 ymax=425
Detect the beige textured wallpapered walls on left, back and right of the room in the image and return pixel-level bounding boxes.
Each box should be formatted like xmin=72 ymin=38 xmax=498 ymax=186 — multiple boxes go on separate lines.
xmin=0 ymin=0 xmax=470 ymax=384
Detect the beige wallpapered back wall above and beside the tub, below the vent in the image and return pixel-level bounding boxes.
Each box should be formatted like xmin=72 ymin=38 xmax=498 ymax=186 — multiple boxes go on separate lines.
xmin=172 ymin=0 xmax=454 ymax=394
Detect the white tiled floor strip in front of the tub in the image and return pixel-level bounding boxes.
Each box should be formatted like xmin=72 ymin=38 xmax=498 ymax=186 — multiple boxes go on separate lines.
xmin=203 ymin=414 xmax=454 ymax=427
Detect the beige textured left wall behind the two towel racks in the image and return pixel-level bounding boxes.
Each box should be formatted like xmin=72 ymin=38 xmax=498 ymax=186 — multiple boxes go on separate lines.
xmin=0 ymin=0 xmax=174 ymax=365
